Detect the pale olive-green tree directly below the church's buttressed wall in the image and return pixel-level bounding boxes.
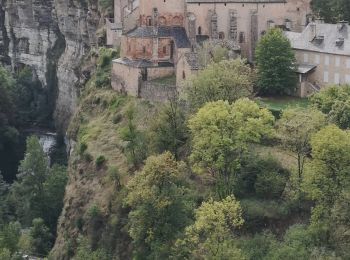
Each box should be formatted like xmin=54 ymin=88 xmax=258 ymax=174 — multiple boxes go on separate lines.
xmin=185 ymin=59 xmax=255 ymax=109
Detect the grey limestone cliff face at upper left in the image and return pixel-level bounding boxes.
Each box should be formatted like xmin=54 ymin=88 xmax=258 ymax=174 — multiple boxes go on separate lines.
xmin=0 ymin=0 xmax=100 ymax=129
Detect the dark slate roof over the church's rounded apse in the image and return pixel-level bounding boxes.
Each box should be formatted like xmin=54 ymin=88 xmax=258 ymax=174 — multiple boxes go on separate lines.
xmin=126 ymin=26 xmax=191 ymax=48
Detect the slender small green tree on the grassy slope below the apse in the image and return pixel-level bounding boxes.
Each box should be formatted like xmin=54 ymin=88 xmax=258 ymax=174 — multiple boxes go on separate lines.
xmin=119 ymin=106 xmax=146 ymax=168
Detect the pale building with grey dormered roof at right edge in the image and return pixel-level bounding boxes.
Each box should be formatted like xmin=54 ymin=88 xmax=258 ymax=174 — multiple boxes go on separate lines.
xmin=286 ymin=20 xmax=350 ymax=96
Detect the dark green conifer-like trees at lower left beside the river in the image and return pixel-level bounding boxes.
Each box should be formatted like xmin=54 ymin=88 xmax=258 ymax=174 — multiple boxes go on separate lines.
xmin=8 ymin=136 xmax=67 ymax=232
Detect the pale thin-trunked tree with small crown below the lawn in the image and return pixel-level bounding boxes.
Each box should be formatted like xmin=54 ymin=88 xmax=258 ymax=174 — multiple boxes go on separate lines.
xmin=277 ymin=107 xmax=326 ymax=189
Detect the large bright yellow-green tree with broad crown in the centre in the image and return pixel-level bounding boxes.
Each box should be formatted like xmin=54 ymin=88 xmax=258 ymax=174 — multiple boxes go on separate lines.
xmin=188 ymin=99 xmax=274 ymax=198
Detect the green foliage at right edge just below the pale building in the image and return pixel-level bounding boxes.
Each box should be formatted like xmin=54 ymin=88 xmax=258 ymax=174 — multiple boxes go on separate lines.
xmin=310 ymin=85 xmax=350 ymax=129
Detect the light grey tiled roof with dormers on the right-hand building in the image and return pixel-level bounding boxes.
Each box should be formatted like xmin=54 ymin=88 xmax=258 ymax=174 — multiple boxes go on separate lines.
xmin=285 ymin=23 xmax=350 ymax=56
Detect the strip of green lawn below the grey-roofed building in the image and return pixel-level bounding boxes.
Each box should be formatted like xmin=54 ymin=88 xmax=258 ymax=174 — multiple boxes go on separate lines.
xmin=256 ymin=97 xmax=310 ymax=111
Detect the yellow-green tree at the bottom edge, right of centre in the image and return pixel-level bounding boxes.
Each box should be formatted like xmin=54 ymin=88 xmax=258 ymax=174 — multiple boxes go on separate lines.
xmin=175 ymin=196 xmax=245 ymax=260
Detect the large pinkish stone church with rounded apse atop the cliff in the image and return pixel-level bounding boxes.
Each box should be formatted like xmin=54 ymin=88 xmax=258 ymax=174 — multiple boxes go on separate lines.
xmin=112 ymin=0 xmax=311 ymax=97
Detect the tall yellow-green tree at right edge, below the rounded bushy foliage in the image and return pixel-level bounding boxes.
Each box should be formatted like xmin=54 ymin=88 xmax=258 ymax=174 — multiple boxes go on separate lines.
xmin=304 ymin=125 xmax=350 ymax=223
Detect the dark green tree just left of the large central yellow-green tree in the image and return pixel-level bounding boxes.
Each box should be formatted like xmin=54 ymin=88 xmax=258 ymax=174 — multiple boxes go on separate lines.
xmin=150 ymin=99 xmax=188 ymax=159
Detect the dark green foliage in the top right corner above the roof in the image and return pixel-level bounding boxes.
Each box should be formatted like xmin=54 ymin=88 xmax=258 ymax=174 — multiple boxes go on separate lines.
xmin=311 ymin=0 xmax=350 ymax=23
